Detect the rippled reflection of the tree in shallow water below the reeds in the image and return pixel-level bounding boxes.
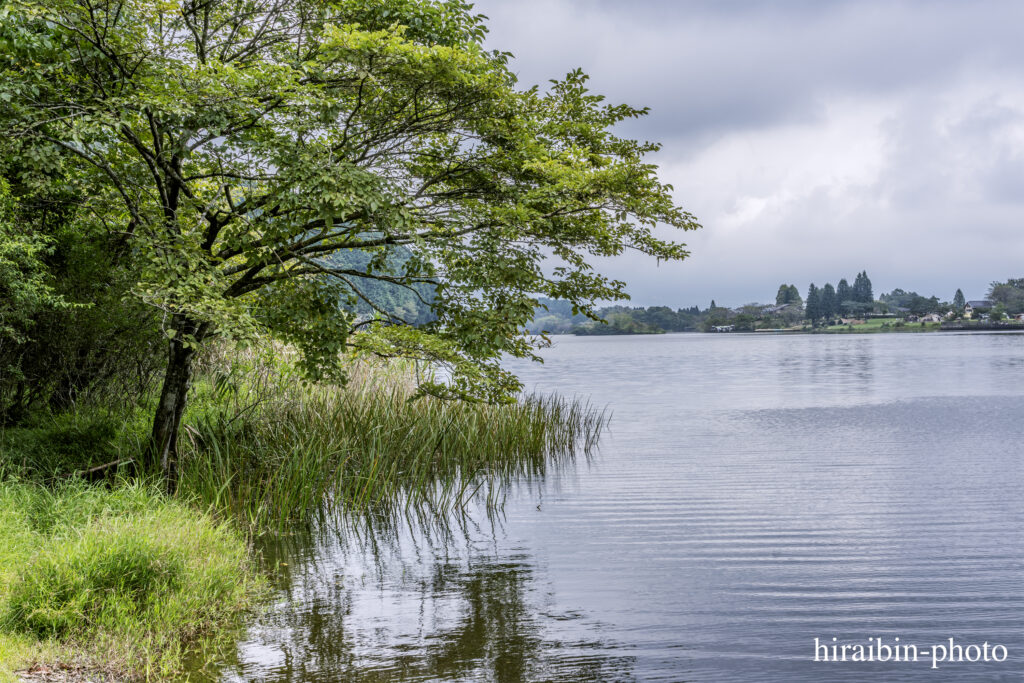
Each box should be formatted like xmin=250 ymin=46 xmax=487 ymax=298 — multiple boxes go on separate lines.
xmin=211 ymin=520 xmax=635 ymax=683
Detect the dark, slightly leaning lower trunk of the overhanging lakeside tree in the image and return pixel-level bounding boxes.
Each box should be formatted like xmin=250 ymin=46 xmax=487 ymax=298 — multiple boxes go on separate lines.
xmin=147 ymin=316 xmax=206 ymax=493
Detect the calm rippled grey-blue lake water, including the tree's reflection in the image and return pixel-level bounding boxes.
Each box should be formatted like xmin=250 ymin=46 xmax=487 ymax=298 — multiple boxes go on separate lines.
xmin=211 ymin=333 xmax=1024 ymax=682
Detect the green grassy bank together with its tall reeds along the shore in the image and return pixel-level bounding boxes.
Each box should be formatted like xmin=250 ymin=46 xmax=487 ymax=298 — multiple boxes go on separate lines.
xmin=0 ymin=353 xmax=605 ymax=681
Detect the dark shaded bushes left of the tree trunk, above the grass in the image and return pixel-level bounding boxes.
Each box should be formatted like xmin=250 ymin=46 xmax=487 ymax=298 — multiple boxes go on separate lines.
xmin=0 ymin=163 xmax=163 ymax=424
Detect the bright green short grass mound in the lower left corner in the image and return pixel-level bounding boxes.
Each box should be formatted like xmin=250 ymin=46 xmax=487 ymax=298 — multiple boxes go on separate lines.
xmin=0 ymin=478 xmax=265 ymax=680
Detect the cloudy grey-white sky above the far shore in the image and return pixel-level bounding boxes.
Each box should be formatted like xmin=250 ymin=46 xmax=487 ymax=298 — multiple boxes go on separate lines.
xmin=475 ymin=0 xmax=1024 ymax=307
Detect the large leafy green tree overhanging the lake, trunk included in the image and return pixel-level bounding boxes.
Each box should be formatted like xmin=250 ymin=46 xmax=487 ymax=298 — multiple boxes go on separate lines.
xmin=0 ymin=0 xmax=697 ymax=481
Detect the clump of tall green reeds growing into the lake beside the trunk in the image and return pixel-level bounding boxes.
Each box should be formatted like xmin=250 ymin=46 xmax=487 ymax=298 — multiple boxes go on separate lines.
xmin=179 ymin=356 xmax=606 ymax=528
